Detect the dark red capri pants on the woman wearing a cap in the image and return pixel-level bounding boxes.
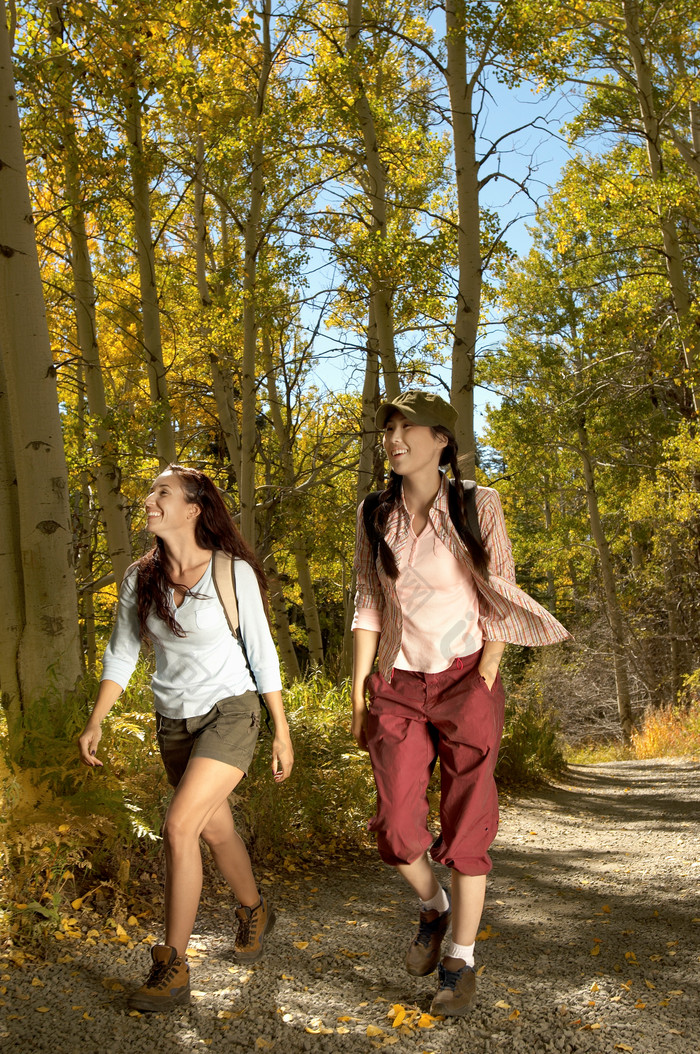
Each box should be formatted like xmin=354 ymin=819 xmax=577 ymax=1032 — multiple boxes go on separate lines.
xmin=367 ymin=651 xmax=505 ymax=875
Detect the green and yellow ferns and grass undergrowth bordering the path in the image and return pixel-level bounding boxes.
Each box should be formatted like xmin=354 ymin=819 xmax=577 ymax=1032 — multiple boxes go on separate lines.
xmin=0 ymin=662 xmax=700 ymax=946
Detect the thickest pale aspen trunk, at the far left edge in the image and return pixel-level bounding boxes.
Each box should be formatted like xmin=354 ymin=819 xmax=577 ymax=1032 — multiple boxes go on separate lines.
xmin=0 ymin=0 xmax=82 ymax=747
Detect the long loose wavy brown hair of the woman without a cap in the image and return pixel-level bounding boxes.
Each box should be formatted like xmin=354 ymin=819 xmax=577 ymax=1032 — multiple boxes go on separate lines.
xmin=136 ymin=465 xmax=268 ymax=642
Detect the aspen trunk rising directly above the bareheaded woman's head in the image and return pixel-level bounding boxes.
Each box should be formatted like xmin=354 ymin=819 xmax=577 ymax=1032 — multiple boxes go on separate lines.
xmin=127 ymin=75 xmax=176 ymax=466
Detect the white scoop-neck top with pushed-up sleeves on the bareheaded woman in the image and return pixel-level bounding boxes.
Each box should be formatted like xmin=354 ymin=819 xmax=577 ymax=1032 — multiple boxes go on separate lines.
xmin=102 ymin=560 xmax=281 ymax=718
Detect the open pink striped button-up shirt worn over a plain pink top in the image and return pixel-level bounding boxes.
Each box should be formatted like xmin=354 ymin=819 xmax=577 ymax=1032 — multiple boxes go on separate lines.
xmin=353 ymin=476 xmax=570 ymax=681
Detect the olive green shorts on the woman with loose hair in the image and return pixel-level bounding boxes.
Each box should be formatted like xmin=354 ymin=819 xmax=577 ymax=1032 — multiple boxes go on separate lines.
xmin=156 ymin=691 xmax=260 ymax=787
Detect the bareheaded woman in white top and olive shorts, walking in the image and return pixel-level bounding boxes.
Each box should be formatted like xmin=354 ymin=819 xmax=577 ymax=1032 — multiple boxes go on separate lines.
xmin=79 ymin=465 xmax=294 ymax=1011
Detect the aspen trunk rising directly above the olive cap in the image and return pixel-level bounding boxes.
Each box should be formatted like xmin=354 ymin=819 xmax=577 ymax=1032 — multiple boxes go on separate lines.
xmin=346 ymin=0 xmax=401 ymax=399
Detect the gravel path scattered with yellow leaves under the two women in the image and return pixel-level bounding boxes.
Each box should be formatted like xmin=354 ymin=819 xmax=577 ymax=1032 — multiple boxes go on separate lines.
xmin=0 ymin=761 xmax=700 ymax=1054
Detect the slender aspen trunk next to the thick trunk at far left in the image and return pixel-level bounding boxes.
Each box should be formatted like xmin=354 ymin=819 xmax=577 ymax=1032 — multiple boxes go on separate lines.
xmin=51 ymin=4 xmax=132 ymax=583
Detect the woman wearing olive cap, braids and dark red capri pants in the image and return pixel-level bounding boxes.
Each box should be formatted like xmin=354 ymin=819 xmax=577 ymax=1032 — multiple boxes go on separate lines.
xmin=352 ymin=391 xmax=569 ymax=1015
